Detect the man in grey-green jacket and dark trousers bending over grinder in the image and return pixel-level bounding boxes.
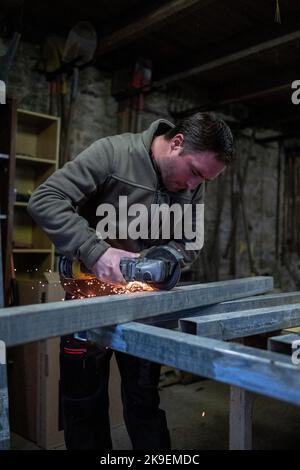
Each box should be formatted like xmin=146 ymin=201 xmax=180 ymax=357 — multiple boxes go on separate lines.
xmin=28 ymin=113 xmax=233 ymax=450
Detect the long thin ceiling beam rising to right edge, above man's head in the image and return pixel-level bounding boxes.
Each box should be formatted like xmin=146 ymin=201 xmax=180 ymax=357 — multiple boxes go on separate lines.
xmin=153 ymin=30 xmax=300 ymax=88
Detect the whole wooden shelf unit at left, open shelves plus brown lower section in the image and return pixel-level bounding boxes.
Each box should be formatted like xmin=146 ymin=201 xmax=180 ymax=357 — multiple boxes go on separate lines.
xmin=7 ymin=109 xmax=63 ymax=448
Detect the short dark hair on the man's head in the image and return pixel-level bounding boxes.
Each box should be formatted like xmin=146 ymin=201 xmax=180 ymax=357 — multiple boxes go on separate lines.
xmin=165 ymin=113 xmax=233 ymax=165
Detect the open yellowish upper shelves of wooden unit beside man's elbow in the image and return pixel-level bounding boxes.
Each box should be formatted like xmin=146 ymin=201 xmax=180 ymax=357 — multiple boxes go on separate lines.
xmin=13 ymin=109 xmax=60 ymax=280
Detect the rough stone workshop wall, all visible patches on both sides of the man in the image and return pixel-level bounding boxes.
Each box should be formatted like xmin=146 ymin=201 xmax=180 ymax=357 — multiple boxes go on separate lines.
xmin=8 ymin=42 xmax=300 ymax=291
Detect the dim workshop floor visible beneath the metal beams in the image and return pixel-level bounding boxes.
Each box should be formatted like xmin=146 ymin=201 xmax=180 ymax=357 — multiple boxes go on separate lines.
xmin=12 ymin=380 xmax=300 ymax=450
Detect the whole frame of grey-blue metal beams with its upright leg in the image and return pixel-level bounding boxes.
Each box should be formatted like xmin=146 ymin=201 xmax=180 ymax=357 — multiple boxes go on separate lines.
xmin=0 ymin=277 xmax=300 ymax=449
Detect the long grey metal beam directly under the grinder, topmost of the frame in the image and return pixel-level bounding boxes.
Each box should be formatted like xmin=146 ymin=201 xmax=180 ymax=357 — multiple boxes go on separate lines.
xmin=0 ymin=277 xmax=273 ymax=346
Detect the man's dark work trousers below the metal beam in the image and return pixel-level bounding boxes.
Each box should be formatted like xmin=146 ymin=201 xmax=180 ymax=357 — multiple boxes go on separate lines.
xmin=60 ymin=336 xmax=171 ymax=451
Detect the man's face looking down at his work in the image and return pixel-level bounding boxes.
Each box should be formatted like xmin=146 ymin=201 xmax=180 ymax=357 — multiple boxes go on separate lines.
xmin=159 ymin=149 xmax=226 ymax=192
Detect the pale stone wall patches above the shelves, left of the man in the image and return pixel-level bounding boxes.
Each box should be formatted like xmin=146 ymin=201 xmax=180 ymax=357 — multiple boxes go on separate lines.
xmin=8 ymin=41 xmax=117 ymax=157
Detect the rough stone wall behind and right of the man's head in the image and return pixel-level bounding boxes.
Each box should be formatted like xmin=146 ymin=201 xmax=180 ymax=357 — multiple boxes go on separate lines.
xmin=141 ymin=93 xmax=300 ymax=291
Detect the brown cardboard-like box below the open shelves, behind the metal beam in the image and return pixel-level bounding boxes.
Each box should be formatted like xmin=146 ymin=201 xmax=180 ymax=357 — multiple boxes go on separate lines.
xmin=8 ymin=272 xmax=64 ymax=449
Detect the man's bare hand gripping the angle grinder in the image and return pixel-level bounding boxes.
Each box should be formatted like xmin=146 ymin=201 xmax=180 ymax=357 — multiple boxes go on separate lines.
xmin=92 ymin=248 xmax=139 ymax=285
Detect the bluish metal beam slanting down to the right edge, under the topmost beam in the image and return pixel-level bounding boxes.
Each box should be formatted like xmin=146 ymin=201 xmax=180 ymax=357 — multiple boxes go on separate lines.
xmin=89 ymin=322 xmax=300 ymax=405
